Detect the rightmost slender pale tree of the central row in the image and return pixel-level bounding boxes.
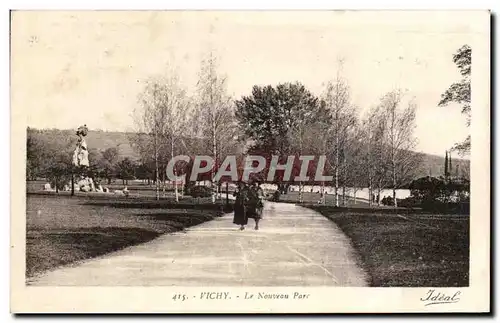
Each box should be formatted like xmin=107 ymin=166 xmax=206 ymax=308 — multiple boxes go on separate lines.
xmin=380 ymin=90 xmax=420 ymax=207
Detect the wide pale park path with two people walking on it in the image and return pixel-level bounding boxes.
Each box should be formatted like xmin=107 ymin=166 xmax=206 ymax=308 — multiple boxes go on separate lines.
xmin=28 ymin=202 xmax=367 ymax=287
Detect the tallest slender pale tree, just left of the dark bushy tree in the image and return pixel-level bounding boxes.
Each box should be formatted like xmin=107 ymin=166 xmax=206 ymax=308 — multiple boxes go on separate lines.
xmin=193 ymin=53 xmax=236 ymax=203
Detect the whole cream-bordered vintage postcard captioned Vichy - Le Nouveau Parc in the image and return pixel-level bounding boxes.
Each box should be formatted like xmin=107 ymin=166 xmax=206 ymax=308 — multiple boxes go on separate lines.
xmin=10 ymin=10 xmax=491 ymax=313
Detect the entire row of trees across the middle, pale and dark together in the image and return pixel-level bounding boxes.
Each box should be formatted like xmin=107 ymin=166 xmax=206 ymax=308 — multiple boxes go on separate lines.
xmin=132 ymin=56 xmax=419 ymax=205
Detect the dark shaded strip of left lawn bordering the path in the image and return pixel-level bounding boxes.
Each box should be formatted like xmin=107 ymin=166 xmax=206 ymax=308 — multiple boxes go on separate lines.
xmin=26 ymin=208 xmax=230 ymax=278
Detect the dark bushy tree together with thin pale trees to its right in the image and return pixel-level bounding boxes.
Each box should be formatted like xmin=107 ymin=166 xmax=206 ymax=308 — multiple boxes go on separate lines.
xmin=236 ymin=76 xmax=420 ymax=206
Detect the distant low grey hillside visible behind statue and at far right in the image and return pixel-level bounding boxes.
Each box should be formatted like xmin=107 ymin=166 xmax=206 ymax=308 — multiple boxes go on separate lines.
xmin=28 ymin=129 xmax=470 ymax=177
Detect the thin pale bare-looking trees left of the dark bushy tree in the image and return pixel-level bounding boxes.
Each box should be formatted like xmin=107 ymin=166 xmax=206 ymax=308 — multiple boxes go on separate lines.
xmin=131 ymin=55 xmax=238 ymax=201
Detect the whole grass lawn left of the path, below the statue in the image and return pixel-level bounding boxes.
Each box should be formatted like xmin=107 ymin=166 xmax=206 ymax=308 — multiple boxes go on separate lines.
xmin=26 ymin=194 xmax=230 ymax=277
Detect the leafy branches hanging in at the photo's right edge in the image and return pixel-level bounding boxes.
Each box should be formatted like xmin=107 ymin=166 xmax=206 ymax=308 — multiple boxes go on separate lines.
xmin=438 ymin=45 xmax=472 ymax=155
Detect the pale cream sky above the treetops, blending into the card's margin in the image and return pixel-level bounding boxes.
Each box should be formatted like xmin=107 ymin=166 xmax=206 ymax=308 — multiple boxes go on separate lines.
xmin=11 ymin=11 xmax=479 ymax=159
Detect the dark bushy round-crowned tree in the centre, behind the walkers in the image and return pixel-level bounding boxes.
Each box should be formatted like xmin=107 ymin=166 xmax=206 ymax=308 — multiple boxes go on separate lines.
xmin=235 ymin=82 xmax=321 ymax=198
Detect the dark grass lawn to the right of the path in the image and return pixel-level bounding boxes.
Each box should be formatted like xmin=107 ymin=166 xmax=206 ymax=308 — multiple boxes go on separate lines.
xmin=309 ymin=206 xmax=469 ymax=287
